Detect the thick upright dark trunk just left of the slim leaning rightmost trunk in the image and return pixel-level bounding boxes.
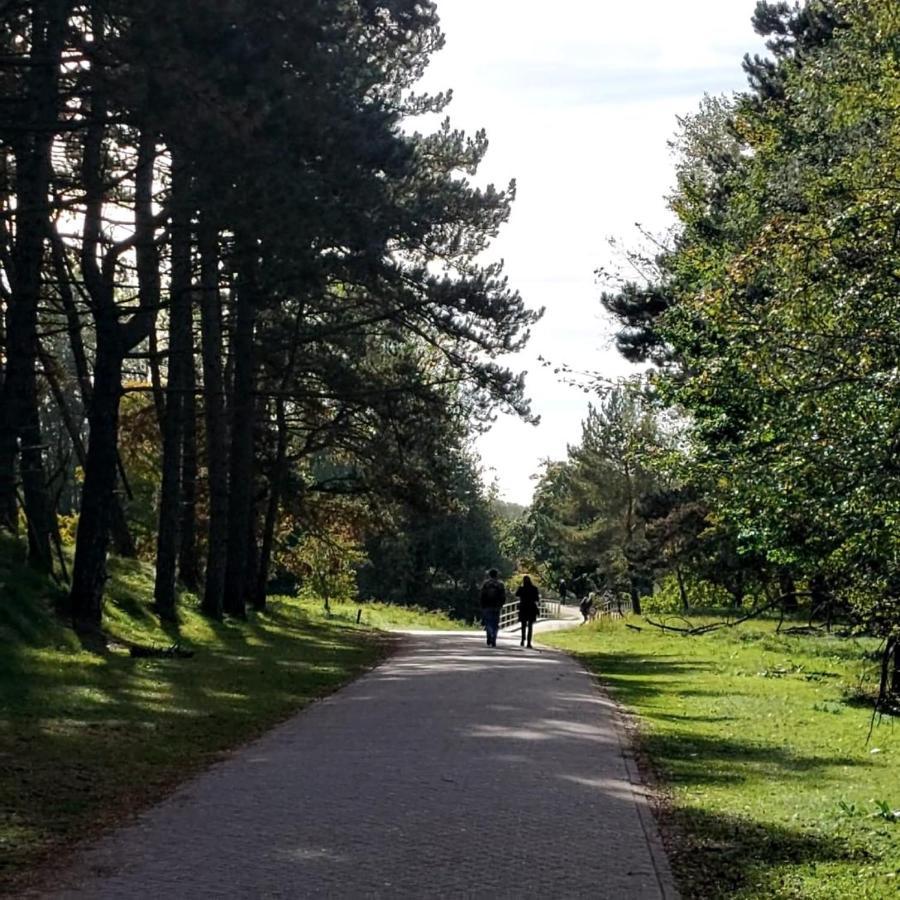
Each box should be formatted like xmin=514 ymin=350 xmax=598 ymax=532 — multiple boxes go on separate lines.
xmin=224 ymin=238 xmax=257 ymax=617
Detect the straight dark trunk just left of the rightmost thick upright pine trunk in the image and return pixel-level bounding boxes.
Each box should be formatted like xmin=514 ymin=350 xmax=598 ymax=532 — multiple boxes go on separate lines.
xmin=199 ymin=213 xmax=228 ymax=618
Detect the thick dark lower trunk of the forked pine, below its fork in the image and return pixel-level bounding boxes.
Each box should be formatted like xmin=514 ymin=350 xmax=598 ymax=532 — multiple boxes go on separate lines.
xmin=70 ymin=319 xmax=124 ymax=631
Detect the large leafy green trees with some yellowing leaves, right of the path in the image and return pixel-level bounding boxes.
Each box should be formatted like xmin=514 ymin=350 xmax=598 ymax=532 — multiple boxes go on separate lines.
xmin=604 ymin=0 xmax=900 ymax=652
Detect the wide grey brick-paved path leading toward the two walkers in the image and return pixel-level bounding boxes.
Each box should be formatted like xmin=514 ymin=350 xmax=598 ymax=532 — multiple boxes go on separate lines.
xmin=44 ymin=632 xmax=676 ymax=900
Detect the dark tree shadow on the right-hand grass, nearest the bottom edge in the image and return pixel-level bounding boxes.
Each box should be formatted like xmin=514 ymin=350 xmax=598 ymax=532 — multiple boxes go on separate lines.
xmin=664 ymin=809 xmax=867 ymax=900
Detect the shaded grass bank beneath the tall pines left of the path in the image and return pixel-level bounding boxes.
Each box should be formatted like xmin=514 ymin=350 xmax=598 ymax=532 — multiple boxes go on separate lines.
xmin=0 ymin=540 xmax=449 ymax=892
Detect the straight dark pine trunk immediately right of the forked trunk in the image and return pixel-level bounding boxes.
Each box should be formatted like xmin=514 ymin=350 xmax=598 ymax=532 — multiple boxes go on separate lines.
xmin=154 ymin=151 xmax=192 ymax=620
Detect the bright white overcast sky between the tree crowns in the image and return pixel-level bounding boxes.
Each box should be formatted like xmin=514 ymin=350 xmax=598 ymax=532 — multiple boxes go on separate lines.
xmin=424 ymin=0 xmax=762 ymax=503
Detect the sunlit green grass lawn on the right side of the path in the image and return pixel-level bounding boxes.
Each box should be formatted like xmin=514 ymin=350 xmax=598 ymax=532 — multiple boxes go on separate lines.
xmin=542 ymin=620 xmax=900 ymax=900
